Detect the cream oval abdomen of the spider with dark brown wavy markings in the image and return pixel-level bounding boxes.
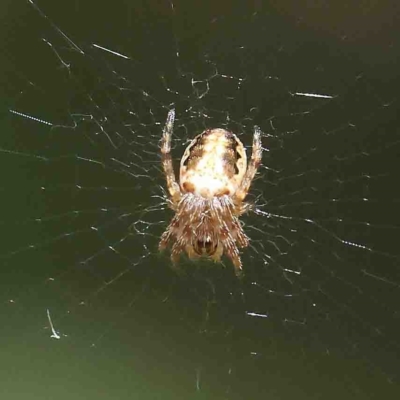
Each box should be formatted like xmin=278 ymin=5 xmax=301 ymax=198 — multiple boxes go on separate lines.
xmin=180 ymin=129 xmax=247 ymax=199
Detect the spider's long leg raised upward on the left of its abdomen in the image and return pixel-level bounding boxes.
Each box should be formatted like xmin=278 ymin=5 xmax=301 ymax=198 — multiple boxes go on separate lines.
xmin=161 ymin=109 xmax=181 ymax=204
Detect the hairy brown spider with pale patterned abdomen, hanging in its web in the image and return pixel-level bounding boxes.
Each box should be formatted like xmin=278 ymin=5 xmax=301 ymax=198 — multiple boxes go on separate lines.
xmin=159 ymin=109 xmax=262 ymax=276
